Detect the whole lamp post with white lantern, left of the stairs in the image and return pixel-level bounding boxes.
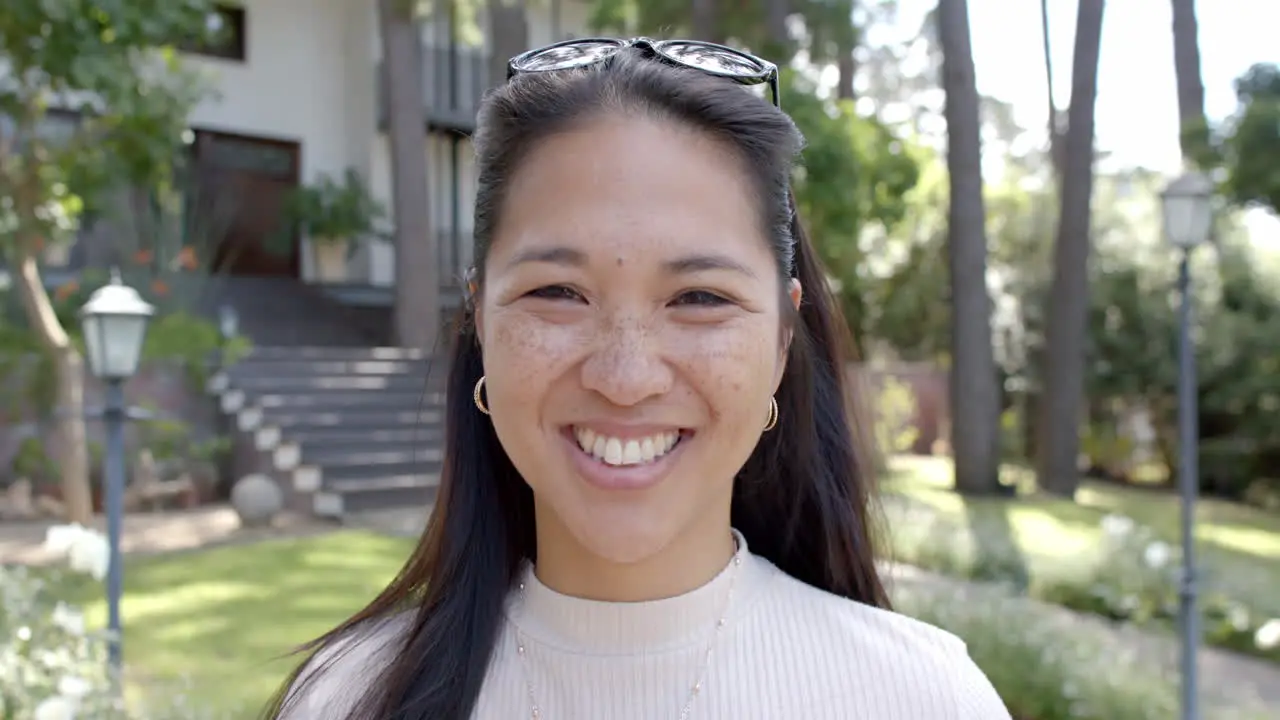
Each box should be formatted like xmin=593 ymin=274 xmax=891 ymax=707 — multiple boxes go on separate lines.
xmin=81 ymin=272 xmax=155 ymax=678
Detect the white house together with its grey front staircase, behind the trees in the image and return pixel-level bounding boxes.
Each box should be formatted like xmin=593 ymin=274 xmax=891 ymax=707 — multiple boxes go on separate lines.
xmin=0 ymin=0 xmax=588 ymax=516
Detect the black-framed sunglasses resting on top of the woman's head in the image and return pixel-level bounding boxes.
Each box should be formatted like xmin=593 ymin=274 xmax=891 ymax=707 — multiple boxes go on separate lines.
xmin=507 ymin=37 xmax=778 ymax=108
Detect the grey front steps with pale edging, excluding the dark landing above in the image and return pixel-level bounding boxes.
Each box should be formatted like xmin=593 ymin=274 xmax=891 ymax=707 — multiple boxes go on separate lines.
xmin=215 ymin=347 xmax=444 ymax=518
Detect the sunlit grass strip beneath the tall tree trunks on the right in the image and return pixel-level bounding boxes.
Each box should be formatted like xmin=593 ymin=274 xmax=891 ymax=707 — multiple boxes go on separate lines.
xmin=883 ymin=457 xmax=1280 ymax=615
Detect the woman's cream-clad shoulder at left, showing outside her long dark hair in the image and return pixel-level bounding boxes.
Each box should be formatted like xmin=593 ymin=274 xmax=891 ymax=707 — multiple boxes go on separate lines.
xmin=278 ymin=614 xmax=411 ymax=720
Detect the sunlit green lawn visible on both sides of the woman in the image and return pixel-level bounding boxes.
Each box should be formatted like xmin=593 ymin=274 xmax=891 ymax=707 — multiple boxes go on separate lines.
xmin=52 ymin=459 xmax=1280 ymax=720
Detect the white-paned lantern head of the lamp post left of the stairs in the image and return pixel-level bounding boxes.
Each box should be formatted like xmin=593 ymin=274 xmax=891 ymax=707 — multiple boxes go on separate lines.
xmin=81 ymin=270 xmax=155 ymax=380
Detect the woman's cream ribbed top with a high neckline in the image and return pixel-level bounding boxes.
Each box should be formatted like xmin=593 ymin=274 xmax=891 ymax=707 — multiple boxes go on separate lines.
xmin=289 ymin=537 xmax=1009 ymax=720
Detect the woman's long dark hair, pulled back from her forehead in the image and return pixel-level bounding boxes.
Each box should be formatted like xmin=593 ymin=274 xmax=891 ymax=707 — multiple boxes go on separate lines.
xmin=268 ymin=50 xmax=888 ymax=720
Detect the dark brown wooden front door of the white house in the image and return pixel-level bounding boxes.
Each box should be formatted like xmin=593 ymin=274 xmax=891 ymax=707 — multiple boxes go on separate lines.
xmin=188 ymin=131 xmax=300 ymax=277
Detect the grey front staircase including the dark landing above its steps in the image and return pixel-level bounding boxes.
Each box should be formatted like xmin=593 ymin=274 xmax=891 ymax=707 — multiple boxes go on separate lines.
xmin=209 ymin=278 xmax=445 ymax=518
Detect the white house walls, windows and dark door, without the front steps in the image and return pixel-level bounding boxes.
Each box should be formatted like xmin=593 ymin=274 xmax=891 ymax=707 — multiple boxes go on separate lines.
xmin=21 ymin=0 xmax=589 ymax=340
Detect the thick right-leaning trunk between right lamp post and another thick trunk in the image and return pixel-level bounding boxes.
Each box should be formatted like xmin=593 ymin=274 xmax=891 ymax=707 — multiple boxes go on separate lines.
xmin=1037 ymin=0 xmax=1105 ymax=497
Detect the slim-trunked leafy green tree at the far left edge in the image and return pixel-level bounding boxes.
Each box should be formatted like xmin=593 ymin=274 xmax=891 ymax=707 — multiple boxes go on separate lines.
xmin=0 ymin=0 xmax=212 ymax=523
